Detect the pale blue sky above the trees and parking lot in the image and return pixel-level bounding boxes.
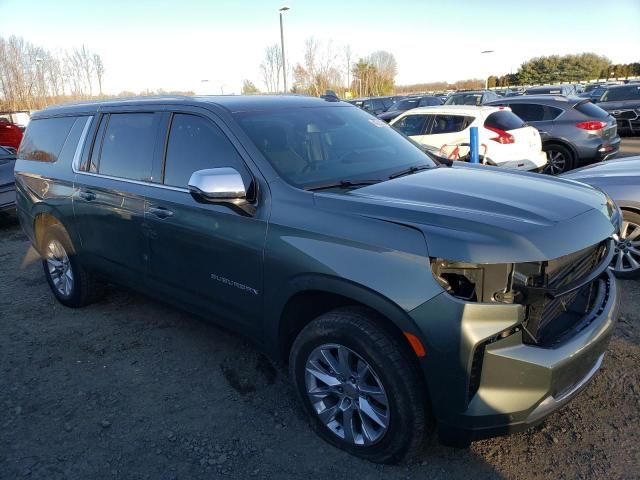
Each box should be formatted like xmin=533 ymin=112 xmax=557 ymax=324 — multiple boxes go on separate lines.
xmin=0 ymin=0 xmax=640 ymax=93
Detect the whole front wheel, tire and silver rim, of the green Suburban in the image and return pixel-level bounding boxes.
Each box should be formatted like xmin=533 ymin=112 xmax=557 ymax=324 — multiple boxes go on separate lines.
xmin=289 ymin=307 xmax=431 ymax=463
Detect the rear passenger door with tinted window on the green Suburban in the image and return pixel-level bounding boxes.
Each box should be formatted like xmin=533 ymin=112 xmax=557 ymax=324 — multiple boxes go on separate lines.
xmin=73 ymin=110 xmax=162 ymax=287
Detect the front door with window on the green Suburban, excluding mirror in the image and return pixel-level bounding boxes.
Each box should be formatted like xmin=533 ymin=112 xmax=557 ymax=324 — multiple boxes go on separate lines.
xmin=145 ymin=112 xmax=268 ymax=325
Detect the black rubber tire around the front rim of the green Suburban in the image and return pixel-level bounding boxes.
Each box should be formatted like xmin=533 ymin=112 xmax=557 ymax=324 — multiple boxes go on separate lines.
xmin=289 ymin=307 xmax=431 ymax=463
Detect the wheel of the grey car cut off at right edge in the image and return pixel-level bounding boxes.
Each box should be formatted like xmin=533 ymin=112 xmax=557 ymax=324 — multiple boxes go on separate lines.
xmin=609 ymin=210 xmax=640 ymax=278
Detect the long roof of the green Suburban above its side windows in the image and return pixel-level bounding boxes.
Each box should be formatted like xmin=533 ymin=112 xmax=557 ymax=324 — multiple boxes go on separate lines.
xmin=31 ymin=95 xmax=353 ymax=116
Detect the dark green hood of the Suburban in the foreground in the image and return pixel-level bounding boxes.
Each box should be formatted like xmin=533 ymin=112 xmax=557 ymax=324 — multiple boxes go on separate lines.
xmin=324 ymin=164 xmax=617 ymax=263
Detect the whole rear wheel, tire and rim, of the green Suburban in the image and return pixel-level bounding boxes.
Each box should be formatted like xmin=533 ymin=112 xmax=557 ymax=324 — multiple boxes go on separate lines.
xmin=40 ymin=225 xmax=104 ymax=308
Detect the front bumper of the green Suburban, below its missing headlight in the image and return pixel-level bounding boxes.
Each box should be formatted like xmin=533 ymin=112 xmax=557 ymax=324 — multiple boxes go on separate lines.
xmin=410 ymin=270 xmax=619 ymax=444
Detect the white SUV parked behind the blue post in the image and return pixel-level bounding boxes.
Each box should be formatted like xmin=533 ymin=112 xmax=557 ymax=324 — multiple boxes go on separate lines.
xmin=391 ymin=105 xmax=547 ymax=171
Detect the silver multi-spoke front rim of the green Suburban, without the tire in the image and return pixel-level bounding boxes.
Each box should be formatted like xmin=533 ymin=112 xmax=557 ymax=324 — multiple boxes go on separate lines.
xmin=305 ymin=344 xmax=390 ymax=445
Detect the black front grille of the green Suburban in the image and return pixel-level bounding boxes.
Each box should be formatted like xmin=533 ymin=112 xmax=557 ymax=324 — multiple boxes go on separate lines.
xmin=525 ymin=243 xmax=606 ymax=345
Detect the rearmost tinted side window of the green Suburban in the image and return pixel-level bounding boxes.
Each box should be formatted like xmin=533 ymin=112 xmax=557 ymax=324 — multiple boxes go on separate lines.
xmin=18 ymin=117 xmax=77 ymax=162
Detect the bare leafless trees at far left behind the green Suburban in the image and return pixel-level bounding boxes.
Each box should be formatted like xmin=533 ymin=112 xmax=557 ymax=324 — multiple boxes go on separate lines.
xmin=0 ymin=36 xmax=105 ymax=110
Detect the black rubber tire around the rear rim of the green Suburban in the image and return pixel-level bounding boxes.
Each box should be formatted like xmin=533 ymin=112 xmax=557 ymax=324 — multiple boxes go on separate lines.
xmin=40 ymin=225 xmax=104 ymax=308
